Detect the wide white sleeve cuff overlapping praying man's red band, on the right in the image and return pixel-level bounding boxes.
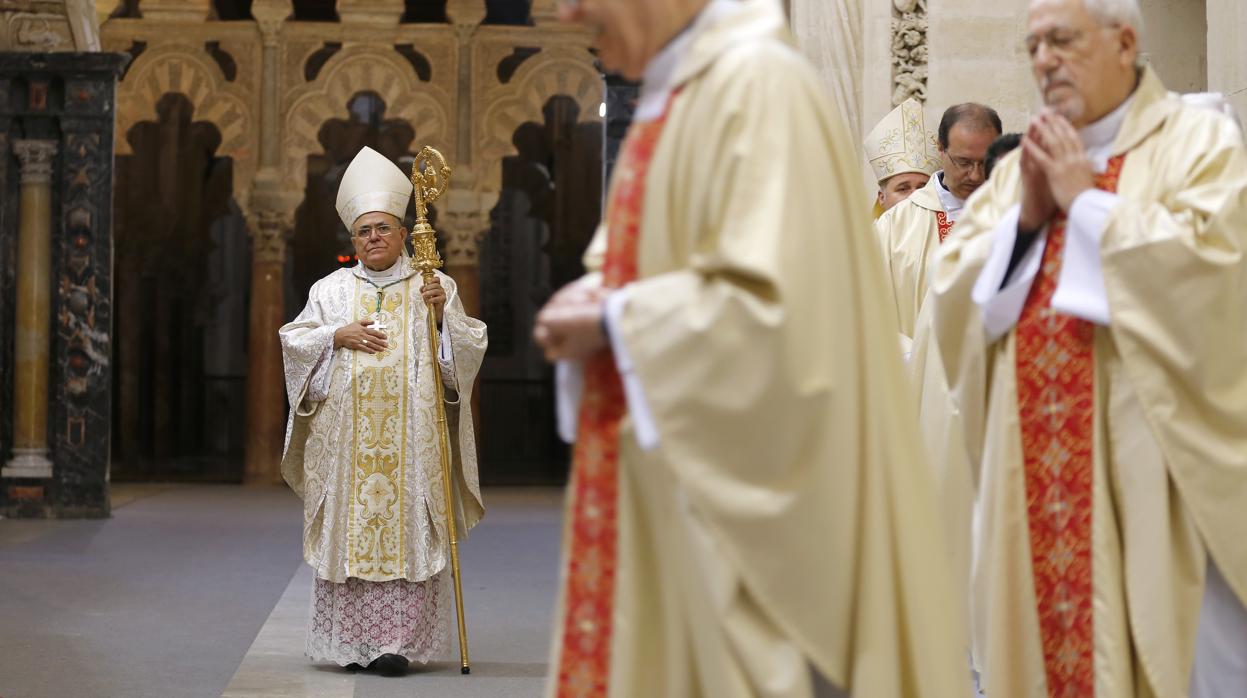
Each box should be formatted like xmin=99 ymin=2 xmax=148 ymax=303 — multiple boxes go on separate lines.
xmin=1052 ymin=189 xmax=1117 ymax=325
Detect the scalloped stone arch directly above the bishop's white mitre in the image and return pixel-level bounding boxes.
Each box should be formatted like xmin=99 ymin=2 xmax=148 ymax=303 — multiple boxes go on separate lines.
xmin=282 ymin=46 xmax=453 ymax=208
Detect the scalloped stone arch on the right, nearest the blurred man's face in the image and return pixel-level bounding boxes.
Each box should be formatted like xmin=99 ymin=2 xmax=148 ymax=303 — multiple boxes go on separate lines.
xmin=476 ymin=49 xmax=606 ymax=199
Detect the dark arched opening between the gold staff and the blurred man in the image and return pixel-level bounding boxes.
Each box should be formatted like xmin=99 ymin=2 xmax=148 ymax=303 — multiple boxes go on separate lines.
xmin=480 ymin=96 xmax=602 ymax=484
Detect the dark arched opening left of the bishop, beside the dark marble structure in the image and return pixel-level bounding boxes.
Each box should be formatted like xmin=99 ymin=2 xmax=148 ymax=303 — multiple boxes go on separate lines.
xmin=112 ymin=93 xmax=251 ymax=481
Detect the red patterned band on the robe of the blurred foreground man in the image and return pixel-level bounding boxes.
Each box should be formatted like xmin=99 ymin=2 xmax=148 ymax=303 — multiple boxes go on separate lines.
xmin=557 ymin=102 xmax=670 ymax=698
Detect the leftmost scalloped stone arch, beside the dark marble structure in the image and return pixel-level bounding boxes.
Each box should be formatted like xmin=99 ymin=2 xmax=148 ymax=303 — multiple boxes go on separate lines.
xmin=116 ymin=44 xmax=259 ymax=208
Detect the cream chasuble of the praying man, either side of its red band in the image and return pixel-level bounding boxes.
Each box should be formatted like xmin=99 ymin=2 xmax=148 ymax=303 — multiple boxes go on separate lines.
xmin=928 ymin=70 xmax=1247 ymax=698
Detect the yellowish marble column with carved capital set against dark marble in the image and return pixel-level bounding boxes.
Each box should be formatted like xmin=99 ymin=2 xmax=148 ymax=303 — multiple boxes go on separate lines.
xmin=0 ymin=141 xmax=57 ymax=477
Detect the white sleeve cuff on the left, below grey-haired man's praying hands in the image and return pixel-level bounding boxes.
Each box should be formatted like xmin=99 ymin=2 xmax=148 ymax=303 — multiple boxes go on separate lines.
xmin=970 ymin=204 xmax=1047 ymax=344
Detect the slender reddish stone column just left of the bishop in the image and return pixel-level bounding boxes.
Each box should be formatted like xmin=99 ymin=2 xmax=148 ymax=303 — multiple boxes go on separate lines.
xmin=243 ymin=0 xmax=297 ymax=485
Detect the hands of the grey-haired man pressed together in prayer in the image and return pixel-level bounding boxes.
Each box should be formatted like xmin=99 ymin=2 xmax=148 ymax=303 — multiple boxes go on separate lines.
xmin=1019 ymin=108 xmax=1095 ymax=231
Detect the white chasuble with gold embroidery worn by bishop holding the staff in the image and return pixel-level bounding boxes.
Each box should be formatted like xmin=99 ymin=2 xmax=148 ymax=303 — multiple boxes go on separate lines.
xmin=281 ymin=262 xmax=486 ymax=582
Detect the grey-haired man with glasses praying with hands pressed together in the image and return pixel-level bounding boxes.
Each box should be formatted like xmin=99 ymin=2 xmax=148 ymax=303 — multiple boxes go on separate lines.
xmin=932 ymin=0 xmax=1247 ymax=698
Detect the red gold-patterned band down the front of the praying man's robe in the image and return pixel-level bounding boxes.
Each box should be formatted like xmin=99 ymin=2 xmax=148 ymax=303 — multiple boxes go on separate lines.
xmin=1016 ymin=156 xmax=1125 ymax=698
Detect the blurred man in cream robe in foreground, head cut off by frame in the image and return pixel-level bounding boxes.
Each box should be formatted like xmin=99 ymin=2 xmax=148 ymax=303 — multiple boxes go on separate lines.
xmin=535 ymin=0 xmax=969 ymax=698
